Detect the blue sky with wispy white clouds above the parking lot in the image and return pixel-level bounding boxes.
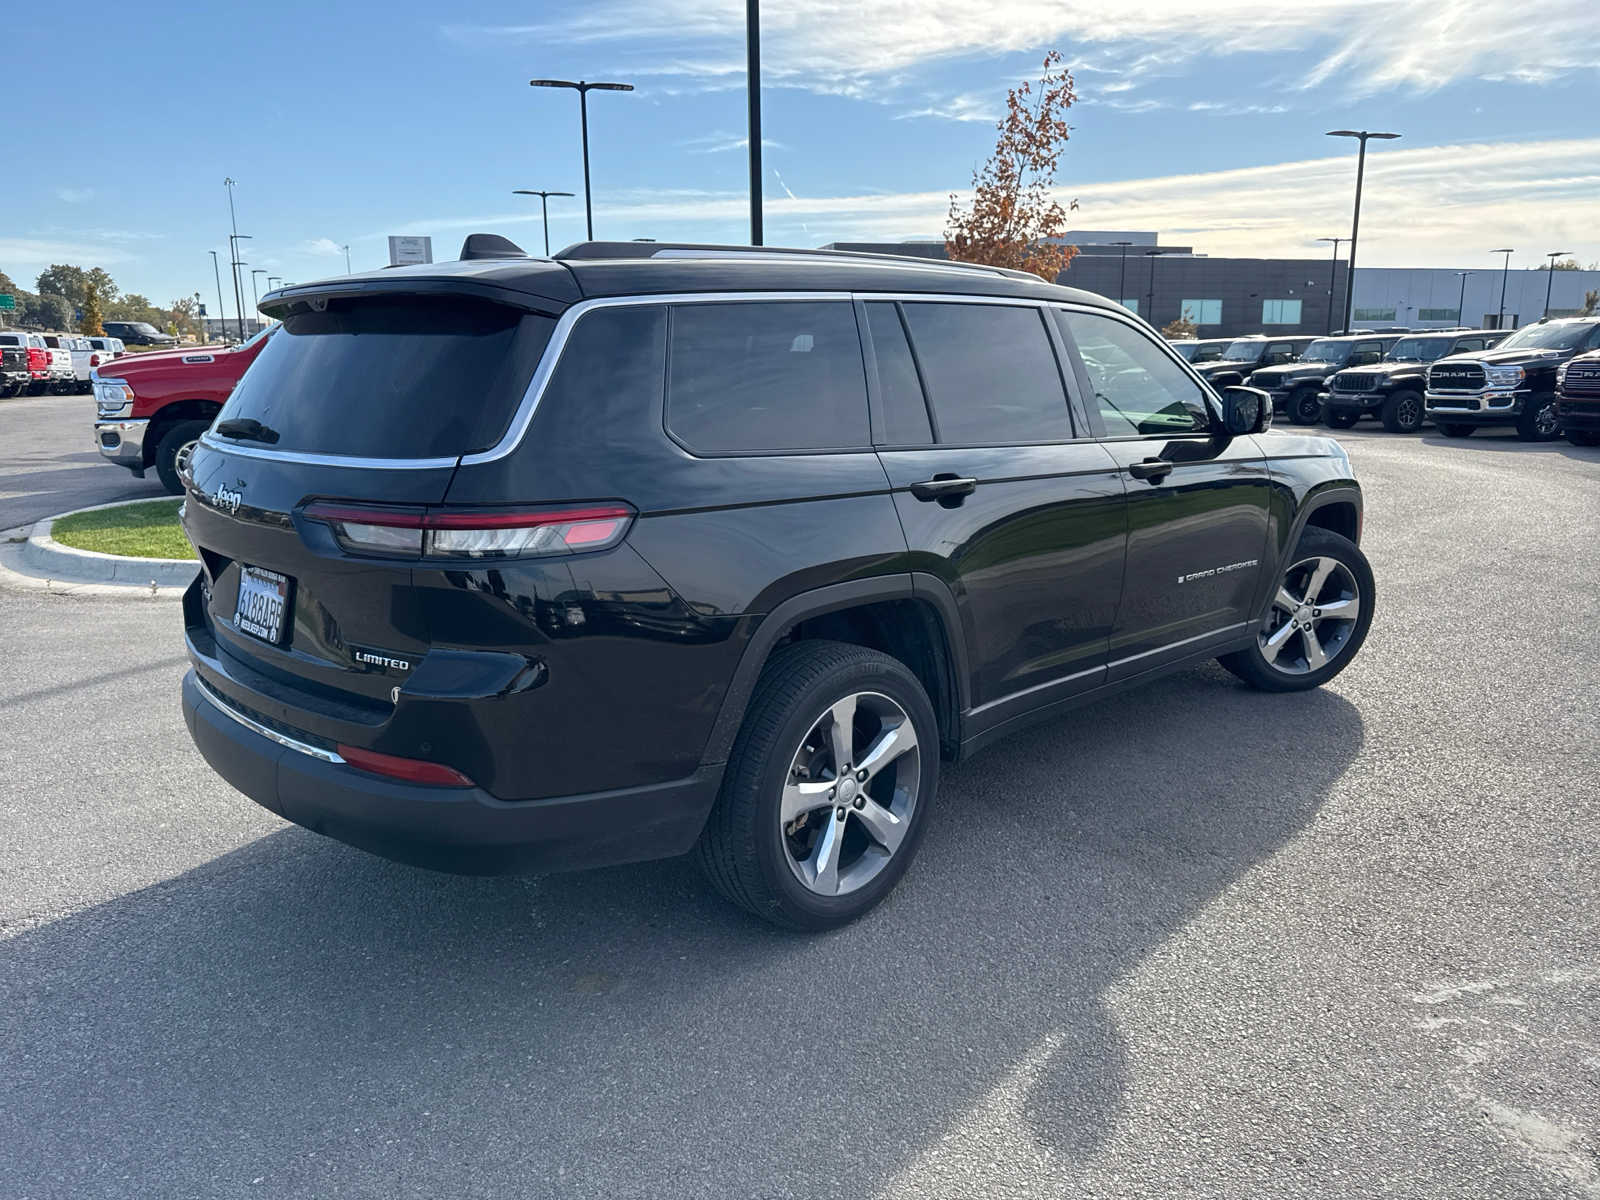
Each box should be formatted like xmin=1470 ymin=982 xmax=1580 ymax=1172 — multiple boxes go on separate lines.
xmin=0 ymin=0 xmax=1600 ymax=315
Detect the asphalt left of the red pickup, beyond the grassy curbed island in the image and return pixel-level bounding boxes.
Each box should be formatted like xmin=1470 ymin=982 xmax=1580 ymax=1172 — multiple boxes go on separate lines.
xmin=0 ymin=395 xmax=166 ymax=530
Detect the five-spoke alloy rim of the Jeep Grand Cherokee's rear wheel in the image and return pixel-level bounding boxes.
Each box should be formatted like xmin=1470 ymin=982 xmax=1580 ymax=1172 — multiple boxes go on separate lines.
xmin=778 ymin=691 xmax=922 ymax=896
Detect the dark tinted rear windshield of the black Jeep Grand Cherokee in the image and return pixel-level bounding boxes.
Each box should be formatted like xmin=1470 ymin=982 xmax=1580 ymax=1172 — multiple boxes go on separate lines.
xmin=216 ymin=296 xmax=555 ymax=458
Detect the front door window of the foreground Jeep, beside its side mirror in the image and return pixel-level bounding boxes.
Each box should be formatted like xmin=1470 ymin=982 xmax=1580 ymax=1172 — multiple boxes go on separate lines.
xmin=1056 ymin=310 xmax=1211 ymax=437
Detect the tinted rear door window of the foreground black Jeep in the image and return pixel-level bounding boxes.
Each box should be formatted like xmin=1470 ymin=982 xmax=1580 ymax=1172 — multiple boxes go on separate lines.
xmin=904 ymin=302 xmax=1072 ymax=443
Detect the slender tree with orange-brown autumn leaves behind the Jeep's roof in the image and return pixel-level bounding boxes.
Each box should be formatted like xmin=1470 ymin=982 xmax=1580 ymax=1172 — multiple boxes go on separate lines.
xmin=944 ymin=50 xmax=1078 ymax=282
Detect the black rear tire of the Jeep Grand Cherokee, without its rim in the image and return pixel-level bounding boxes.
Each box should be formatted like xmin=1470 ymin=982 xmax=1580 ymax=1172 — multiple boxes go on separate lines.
xmin=696 ymin=642 xmax=939 ymax=930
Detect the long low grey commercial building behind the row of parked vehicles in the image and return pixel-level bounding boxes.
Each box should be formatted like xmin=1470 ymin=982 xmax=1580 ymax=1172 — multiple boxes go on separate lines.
xmin=826 ymin=230 xmax=1600 ymax=338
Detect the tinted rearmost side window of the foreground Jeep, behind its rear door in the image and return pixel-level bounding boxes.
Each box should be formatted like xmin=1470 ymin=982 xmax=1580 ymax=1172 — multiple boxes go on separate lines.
xmin=667 ymin=301 xmax=870 ymax=454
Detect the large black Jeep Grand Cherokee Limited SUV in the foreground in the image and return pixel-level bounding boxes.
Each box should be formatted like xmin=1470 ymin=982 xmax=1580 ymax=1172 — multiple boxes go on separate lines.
xmin=182 ymin=235 xmax=1373 ymax=928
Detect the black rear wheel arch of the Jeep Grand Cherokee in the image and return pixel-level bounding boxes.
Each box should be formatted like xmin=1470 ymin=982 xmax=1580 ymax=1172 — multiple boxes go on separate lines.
xmin=701 ymin=571 xmax=970 ymax=763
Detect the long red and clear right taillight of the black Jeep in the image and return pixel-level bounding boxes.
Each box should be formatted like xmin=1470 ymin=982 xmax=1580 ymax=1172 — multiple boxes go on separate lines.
xmin=306 ymin=501 xmax=634 ymax=558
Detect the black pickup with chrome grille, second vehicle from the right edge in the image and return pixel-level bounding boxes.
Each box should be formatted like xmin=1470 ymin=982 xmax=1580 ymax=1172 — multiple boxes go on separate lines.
xmin=1426 ymin=317 xmax=1600 ymax=442
